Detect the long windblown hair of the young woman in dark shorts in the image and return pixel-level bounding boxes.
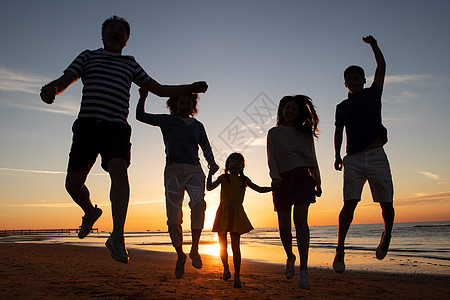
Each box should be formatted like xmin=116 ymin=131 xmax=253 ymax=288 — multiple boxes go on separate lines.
xmin=277 ymin=95 xmax=319 ymax=137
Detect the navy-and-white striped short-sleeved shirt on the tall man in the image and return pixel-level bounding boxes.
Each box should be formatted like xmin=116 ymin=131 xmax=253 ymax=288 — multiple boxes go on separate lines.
xmin=64 ymin=48 xmax=150 ymax=123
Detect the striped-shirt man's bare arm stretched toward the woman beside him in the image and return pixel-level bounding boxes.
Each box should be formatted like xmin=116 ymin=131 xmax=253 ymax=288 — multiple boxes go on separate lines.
xmin=141 ymin=79 xmax=208 ymax=97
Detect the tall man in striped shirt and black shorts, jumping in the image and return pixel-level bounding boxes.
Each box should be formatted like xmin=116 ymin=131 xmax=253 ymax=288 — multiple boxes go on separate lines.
xmin=41 ymin=16 xmax=208 ymax=263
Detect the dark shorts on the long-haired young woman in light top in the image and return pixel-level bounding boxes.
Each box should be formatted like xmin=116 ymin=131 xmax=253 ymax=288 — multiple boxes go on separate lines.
xmin=273 ymin=167 xmax=316 ymax=211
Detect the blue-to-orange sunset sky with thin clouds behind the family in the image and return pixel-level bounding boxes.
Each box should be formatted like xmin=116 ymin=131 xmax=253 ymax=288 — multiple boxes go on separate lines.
xmin=0 ymin=0 xmax=450 ymax=231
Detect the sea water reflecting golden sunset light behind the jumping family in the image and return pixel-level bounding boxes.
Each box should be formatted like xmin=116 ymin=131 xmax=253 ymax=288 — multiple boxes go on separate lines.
xmin=0 ymin=221 xmax=450 ymax=275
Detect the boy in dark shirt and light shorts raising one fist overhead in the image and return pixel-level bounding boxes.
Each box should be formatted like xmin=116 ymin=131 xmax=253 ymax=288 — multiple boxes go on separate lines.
xmin=333 ymin=36 xmax=395 ymax=273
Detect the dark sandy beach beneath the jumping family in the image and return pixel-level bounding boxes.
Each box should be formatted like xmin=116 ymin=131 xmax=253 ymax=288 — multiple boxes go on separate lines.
xmin=0 ymin=243 xmax=450 ymax=299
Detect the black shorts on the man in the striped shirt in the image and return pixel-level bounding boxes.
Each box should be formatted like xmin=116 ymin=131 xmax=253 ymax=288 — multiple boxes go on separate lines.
xmin=67 ymin=118 xmax=131 ymax=172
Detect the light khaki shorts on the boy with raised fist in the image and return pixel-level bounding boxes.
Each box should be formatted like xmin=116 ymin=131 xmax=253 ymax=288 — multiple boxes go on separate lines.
xmin=343 ymin=147 xmax=394 ymax=202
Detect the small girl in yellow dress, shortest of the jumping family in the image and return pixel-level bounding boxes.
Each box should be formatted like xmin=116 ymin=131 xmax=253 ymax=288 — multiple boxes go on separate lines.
xmin=206 ymin=153 xmax=272 ymax=288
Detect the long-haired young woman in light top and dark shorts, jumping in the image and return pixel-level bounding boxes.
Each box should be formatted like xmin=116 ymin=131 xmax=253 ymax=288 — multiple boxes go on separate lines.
xmin=267 ymin=95 xmax=322 ymax=289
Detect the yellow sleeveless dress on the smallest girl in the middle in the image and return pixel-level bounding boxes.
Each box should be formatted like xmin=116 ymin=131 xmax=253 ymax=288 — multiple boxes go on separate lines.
xmin=212 ymin=174 xmax=253 ymax=234
